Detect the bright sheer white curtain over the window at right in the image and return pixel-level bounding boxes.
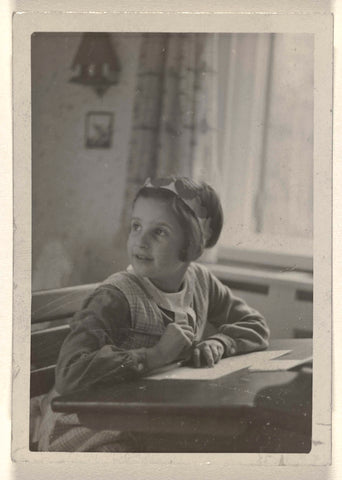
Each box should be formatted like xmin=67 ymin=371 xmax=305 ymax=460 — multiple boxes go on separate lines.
xmin=218 ymin=34 xmax=313 ymax=265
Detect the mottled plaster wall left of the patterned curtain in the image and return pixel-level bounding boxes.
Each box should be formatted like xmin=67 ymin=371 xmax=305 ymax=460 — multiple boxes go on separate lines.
xmin=32 ymin=33 xmax=140 ymax=290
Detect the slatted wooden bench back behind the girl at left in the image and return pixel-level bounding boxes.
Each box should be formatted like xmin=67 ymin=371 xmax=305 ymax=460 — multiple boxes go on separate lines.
xmin=30 ymin=284 xmax=97 ymax=398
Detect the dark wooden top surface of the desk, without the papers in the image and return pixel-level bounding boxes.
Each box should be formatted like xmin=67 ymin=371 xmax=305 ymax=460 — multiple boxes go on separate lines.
xmin=52 ymin=339 xmax=312 ymax=415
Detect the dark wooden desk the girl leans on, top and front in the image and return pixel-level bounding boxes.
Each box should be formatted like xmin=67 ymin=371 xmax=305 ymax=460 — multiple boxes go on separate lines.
xmin=52 ymin=339 xmax=312 ymax=453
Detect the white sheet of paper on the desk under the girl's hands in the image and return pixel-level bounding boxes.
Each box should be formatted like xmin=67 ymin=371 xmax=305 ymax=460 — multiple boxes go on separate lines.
xmin=146 ymin=350 xmax=291 ymax=380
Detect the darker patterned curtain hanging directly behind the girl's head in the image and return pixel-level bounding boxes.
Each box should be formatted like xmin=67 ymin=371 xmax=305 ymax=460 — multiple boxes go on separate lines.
xmin=115 ymin=33 xmax=220 ymax=264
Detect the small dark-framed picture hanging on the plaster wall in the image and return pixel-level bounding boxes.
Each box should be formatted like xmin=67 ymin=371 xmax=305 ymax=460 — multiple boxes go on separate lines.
xmin=85 ymin=112 xmax=114 ymax=148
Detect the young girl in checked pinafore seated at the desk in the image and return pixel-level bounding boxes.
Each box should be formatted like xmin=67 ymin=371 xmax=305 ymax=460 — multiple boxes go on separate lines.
xmin=35 ymin=177 xmax=269 ymax=451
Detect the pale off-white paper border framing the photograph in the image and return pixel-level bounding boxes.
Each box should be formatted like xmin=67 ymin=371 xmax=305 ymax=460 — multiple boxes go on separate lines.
xmin=7 ymin=1 xmax=332 ymax=478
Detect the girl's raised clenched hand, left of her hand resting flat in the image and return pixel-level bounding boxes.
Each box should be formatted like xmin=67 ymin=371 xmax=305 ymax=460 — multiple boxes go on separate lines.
xmin=146 ymin=322 xmax=194 ymax=369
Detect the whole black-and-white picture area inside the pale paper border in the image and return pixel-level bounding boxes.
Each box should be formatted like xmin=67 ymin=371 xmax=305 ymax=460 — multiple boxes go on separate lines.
xmin=11 ymin=8 xmax=330 ymax=472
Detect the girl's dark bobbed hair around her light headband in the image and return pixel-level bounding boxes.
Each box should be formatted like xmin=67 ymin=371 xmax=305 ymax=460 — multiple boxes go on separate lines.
xmin=133 ymin=176 xmax=223 ymax=262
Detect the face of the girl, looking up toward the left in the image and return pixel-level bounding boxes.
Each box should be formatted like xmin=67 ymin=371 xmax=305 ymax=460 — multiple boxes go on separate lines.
xmin=127 ymin=197 xmax=188 ymax=292
